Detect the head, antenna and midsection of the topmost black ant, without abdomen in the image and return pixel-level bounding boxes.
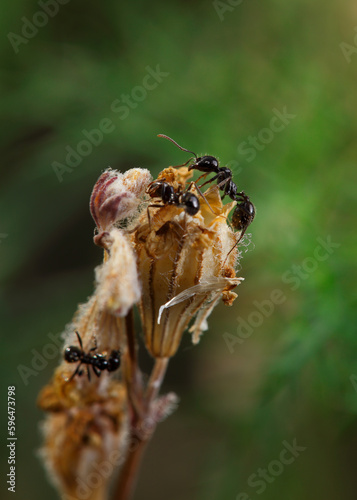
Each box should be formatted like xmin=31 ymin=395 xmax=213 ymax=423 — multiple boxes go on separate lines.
xmin=158 ymin=134 xmax=238 ymax=201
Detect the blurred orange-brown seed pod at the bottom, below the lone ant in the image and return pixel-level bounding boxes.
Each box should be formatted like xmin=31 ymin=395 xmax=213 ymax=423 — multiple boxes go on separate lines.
xmin=39 ymin=377 xmax=129 ymax=500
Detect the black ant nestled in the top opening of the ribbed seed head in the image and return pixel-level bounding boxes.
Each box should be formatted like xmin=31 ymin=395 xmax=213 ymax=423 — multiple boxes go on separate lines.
xmin=146 ymin=180 xmax=200 ymax=219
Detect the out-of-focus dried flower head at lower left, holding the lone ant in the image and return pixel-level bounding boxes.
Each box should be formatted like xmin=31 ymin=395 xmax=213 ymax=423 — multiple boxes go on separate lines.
xmin=38 ymin=295 xmax=129 ymax=500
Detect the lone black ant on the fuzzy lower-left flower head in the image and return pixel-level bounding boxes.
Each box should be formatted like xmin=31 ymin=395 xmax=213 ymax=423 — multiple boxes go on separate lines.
xmin=63 ymin=332 xmax=120 ymax=382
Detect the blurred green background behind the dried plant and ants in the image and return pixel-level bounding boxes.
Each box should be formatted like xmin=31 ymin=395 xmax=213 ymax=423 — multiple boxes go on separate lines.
xmin=0 ymin=0 xmax=357 ymax=500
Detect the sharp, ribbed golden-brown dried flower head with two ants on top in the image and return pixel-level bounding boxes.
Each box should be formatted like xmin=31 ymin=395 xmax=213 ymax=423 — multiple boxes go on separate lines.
xmin=133 ymin=168 xmax=240 ymax=358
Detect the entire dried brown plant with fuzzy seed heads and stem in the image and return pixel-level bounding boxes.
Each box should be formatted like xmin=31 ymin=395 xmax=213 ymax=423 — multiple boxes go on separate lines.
xmin=38 ymin=167 xmax=248 ymax=500
